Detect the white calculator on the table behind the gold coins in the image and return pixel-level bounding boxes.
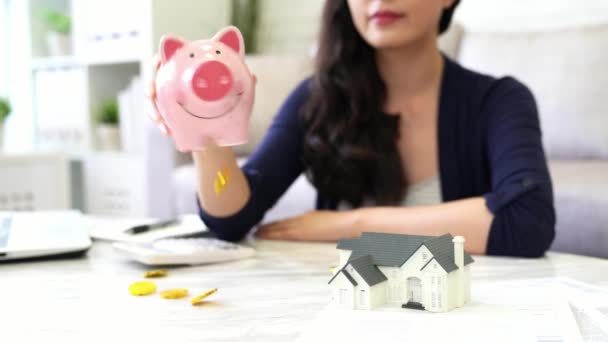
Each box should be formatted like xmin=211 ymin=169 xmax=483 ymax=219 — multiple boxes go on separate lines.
xmin=113 ymin=237 xmax=255 ymax=265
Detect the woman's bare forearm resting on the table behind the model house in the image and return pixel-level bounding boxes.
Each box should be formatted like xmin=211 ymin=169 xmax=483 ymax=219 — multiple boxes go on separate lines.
xmin=349 ymin=197 xmax=493 ymax=254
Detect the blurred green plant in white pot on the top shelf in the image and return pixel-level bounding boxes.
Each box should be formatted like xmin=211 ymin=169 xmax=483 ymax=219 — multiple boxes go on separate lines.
xmin=39 ymin=10 xmax=72 ymax=56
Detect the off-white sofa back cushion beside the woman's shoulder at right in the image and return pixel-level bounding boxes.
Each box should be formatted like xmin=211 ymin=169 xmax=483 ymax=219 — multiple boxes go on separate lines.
xmin=459 ymin=23 xmax=608 ymax=159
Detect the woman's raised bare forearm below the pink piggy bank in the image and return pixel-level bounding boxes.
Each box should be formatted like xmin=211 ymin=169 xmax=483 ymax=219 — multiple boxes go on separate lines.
xmin=192 ymin=146 xmax=251 ymax=217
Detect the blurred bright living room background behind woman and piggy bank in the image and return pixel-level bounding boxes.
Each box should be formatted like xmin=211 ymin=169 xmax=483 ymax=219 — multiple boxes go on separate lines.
xmin=0 ymin=0 xmax=608 ymax=256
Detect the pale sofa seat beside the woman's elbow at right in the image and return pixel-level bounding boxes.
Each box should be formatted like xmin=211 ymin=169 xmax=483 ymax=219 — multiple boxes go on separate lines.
xmin=549 ymin=161 xmax=608 ymax=258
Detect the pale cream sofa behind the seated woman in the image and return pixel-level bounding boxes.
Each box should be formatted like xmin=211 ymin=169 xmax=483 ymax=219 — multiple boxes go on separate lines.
xmin=147 ymin=22 xmax=608 ymax=258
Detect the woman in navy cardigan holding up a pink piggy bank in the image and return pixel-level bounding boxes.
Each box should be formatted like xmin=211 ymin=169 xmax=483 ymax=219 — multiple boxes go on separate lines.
xmin=152 ymin=0 xmax=555 ymax=257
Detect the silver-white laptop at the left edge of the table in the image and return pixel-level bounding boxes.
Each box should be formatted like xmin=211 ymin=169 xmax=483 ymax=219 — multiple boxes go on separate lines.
xmin=0 ymin=211 xmax=91 ymax=261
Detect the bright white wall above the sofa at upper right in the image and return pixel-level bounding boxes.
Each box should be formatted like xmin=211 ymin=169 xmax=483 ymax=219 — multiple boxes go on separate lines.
xmin=455 ymin=0 xmax=608 ymax=30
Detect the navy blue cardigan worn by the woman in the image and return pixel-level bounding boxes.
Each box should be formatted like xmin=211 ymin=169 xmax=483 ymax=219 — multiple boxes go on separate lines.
xmin=199 ymin=58 xmax=555 ymax=257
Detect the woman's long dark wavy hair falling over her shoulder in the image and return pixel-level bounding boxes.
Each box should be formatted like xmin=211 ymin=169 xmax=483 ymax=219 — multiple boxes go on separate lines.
xmin=301 ymin=0 xmax=459 ymax=207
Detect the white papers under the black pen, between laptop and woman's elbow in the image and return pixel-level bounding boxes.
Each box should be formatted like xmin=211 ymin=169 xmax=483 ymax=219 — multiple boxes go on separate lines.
xmin=87 ymin=215 xmax=208 ymax=243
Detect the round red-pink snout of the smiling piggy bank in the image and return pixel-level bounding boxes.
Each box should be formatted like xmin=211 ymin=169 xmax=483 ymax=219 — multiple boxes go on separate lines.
xmin=192 ymin=61 xmax=233 ymax=101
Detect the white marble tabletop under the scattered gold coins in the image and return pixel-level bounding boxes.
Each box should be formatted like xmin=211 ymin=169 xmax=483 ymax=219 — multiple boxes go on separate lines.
xmin=0 ymin=235 xmax=608 ymax=341
